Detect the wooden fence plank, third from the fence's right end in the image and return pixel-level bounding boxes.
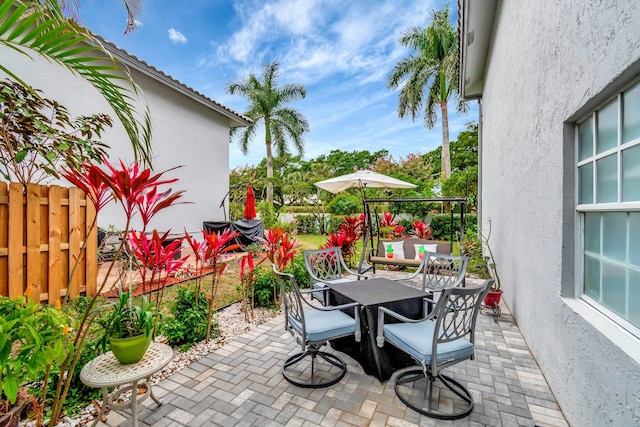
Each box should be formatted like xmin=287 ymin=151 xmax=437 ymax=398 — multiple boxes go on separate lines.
xmin=47 ymin=185 xmax=62 ymax=305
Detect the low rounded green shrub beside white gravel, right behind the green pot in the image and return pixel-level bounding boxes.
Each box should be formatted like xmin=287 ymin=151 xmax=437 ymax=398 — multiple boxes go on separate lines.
xmin=161 ymin=287 xmax=211 ymax=348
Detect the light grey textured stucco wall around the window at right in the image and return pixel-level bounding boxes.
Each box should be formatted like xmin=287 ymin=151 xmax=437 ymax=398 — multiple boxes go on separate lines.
xmin=481 ymin=0 xmax=640 ymax=426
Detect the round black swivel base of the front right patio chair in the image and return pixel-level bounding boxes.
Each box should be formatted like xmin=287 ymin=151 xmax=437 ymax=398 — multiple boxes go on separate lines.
xmin=394 ymin=368 xmax=473 ymax=420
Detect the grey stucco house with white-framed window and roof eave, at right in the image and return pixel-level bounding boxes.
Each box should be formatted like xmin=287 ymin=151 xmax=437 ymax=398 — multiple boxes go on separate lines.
xmin=459 ymin=0 xmax=640 ymax=426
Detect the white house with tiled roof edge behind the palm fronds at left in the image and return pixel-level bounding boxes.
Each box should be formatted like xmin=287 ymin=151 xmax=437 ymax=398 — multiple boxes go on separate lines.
xmin=0 ymin=38 xmax=250 ymax=233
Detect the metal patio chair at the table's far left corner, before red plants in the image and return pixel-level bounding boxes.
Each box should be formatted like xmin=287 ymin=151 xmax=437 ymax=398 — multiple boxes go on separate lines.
xmin=302 ymin=247 xmax=368 ymax=305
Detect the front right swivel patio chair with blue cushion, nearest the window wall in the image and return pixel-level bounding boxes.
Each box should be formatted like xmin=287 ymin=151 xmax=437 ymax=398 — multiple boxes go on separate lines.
xmin=376 ymin=280 xmax=493 ymax=420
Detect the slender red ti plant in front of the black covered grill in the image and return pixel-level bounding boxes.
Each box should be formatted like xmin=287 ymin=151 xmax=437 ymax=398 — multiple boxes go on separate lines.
xmin=202 ymin=228 xmax=242 ymax=342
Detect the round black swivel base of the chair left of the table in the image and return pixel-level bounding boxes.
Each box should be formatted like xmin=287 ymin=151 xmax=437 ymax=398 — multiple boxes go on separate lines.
xmin=282 ymin=346 xmax=347 ymax=388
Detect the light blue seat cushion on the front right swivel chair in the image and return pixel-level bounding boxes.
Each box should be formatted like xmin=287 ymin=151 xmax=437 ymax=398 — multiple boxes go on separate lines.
xmin=384 ymin=320 xmax=473 ymax=365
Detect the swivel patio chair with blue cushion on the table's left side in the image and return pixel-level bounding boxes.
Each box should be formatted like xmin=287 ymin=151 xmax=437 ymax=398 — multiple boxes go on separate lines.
xmin=272 ymin=266 xmax=361 ymax=388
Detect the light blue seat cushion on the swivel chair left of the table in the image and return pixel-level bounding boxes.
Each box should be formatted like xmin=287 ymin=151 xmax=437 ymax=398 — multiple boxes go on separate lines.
xmin=289 ymin=309 xmax=356 ymax=342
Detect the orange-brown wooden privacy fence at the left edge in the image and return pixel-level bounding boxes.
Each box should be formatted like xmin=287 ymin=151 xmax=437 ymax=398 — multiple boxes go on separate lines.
xmin=0 ymin=182 xmax=97 ymax=304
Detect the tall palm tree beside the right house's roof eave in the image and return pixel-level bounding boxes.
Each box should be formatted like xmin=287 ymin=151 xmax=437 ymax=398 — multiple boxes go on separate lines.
xmin=387 ymin=8 xmax=467 ymax=179
